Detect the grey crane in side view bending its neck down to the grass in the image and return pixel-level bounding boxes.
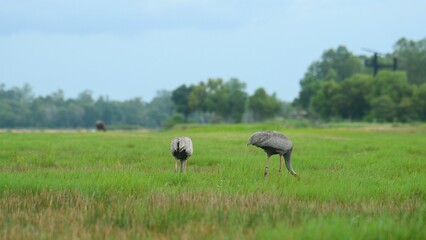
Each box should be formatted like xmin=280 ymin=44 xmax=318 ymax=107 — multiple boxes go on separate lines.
xmin=247 ymin=131 xmax=299 ymax=177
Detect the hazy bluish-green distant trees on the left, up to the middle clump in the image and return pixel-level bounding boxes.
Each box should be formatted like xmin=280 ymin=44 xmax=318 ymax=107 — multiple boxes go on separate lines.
xmin=0 ymin=84 xmax=175 ymax=128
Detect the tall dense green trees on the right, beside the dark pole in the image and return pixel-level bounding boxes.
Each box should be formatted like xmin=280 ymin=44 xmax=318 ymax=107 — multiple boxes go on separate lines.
xmin=293 ymin=38 xmax=426 ymax=122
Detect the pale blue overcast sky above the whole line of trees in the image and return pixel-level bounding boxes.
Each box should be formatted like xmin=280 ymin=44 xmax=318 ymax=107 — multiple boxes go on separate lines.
xmin=0 ymin=0 xmax=426 ymax=101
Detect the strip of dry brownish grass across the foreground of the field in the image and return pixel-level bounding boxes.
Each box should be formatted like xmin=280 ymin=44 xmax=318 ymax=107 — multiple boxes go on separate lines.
xmin=0 ymin=190 xmax=425 ymax=239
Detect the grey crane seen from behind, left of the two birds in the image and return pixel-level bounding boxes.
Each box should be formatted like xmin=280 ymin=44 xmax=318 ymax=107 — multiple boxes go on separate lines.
xmin=170 ymin=137 xmax=193 ymax=172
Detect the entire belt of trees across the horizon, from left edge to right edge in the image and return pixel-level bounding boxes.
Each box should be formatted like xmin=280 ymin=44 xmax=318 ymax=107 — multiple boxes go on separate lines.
xmin=0 ymin=38 xmax=426 ymax=129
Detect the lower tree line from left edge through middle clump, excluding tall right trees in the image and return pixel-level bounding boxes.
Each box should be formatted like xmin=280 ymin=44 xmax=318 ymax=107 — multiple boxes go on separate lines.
xmin=0 ymin=78 xmax=290 ymax=129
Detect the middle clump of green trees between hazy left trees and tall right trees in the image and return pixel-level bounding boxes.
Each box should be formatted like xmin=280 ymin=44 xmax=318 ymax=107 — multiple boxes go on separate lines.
xmin=172 ymin=78 xmax=284 ymax=123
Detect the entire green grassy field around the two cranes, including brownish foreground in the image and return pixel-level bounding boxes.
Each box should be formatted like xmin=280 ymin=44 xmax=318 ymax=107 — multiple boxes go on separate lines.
xmin=0 ymin=124 xmax=426 ymax=239
